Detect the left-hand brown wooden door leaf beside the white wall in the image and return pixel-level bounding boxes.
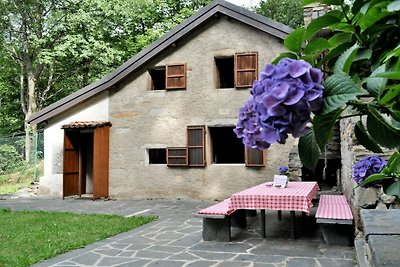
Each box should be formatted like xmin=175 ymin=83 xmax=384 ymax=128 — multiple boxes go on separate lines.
xmin=63 ymin=131 xmax=80 ymax=198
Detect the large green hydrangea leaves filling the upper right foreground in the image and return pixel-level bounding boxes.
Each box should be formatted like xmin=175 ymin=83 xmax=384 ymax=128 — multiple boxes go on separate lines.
xmin=274 ymin=0 xmax=400 ymax=195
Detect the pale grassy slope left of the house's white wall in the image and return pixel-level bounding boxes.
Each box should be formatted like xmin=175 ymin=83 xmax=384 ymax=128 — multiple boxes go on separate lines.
xmin=0 ymin=161 xmax=43 ymax=195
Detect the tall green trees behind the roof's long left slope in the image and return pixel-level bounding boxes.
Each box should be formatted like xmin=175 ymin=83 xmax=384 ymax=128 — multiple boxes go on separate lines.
xmin=0 ymin=0 xmax=210 ymax=161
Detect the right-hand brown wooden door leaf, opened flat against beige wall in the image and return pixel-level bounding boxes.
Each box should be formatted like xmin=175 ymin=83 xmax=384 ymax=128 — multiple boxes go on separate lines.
xmin=93 ymin=126 xmax=110 ymax=199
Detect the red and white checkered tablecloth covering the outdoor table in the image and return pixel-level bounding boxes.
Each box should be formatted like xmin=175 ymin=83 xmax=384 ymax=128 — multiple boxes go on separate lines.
xmin=229 ymin=182 xmax=319 ymax=213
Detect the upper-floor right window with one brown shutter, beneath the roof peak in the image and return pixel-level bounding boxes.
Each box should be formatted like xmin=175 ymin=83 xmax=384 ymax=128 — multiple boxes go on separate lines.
xmin=215 ymin=52 xmax=258 ymax=89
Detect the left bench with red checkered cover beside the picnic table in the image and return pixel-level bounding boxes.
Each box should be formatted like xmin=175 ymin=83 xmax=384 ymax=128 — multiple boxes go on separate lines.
xmin=196 ymin=198 xmax=247 ymax=242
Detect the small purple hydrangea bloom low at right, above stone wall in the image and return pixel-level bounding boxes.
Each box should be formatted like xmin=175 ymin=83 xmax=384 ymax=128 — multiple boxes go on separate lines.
xmin=353 ymin=155 xmax=387 ymax=186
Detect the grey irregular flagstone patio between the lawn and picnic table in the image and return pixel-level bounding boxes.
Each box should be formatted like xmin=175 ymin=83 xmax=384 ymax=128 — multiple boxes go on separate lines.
xmin=0 ymin=197 xmax=356 ymax=267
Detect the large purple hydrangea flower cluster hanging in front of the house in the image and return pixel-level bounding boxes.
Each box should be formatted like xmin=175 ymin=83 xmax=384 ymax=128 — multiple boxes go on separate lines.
xmin=234 ymin=58 xmax=324 ymax=149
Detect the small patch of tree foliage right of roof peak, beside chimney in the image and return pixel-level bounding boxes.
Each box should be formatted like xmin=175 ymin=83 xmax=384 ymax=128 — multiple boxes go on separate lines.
xmin=255 ymin=0 xmax=304 ymax=29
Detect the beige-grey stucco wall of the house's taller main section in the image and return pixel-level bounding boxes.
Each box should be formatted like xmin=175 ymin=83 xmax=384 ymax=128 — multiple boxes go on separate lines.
xmin=110 ymin=16 xmax=294 ymax=199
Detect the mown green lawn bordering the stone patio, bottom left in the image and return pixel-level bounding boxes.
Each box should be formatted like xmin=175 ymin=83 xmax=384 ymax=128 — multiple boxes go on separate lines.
xmin=0 ymin=209 xmax=156 ymax=267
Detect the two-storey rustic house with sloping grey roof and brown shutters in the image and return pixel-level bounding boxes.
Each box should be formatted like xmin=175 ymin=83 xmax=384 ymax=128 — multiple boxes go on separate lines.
xmin=28 ymin=1 xmax=296 ymax=199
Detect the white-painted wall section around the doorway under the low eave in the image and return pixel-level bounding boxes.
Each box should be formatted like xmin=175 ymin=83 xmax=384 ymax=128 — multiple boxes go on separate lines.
xmin=38 ymin=92 xmax=109 ymax=195
